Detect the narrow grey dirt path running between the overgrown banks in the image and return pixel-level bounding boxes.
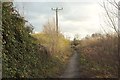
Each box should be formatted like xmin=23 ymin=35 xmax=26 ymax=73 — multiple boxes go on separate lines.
xmin=60 ymin=53 xmax=80 ymax=78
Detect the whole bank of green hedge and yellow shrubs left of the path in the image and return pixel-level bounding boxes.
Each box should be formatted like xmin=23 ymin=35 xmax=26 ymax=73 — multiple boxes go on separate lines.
xmin=2 ymin=2 xmax=71 ymax=78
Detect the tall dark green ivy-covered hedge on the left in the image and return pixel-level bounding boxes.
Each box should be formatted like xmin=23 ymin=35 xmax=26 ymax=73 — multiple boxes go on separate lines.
xmin=2 ymin=2 xmax=47 ymax=77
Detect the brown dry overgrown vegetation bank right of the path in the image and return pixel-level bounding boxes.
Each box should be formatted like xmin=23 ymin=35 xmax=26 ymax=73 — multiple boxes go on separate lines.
xmin=78 ymin=35 xmax=118 ymax=78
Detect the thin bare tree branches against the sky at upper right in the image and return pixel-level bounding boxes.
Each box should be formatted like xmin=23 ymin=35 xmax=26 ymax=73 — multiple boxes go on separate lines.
xmin=100 ymin=0 xmax=120 ymax=36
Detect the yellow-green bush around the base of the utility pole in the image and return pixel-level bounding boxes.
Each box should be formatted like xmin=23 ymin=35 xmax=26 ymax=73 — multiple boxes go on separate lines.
xmin=32 ymin=33 xmax=71 ymax=62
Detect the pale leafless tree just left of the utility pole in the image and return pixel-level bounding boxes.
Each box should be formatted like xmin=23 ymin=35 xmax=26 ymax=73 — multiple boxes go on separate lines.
xmin=43 ymin=19 xmax=58 ymax=54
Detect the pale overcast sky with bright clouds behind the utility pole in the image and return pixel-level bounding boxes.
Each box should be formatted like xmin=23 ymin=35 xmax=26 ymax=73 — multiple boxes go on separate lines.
xmin=12 ymin=0 xmax=115 ymax=39
